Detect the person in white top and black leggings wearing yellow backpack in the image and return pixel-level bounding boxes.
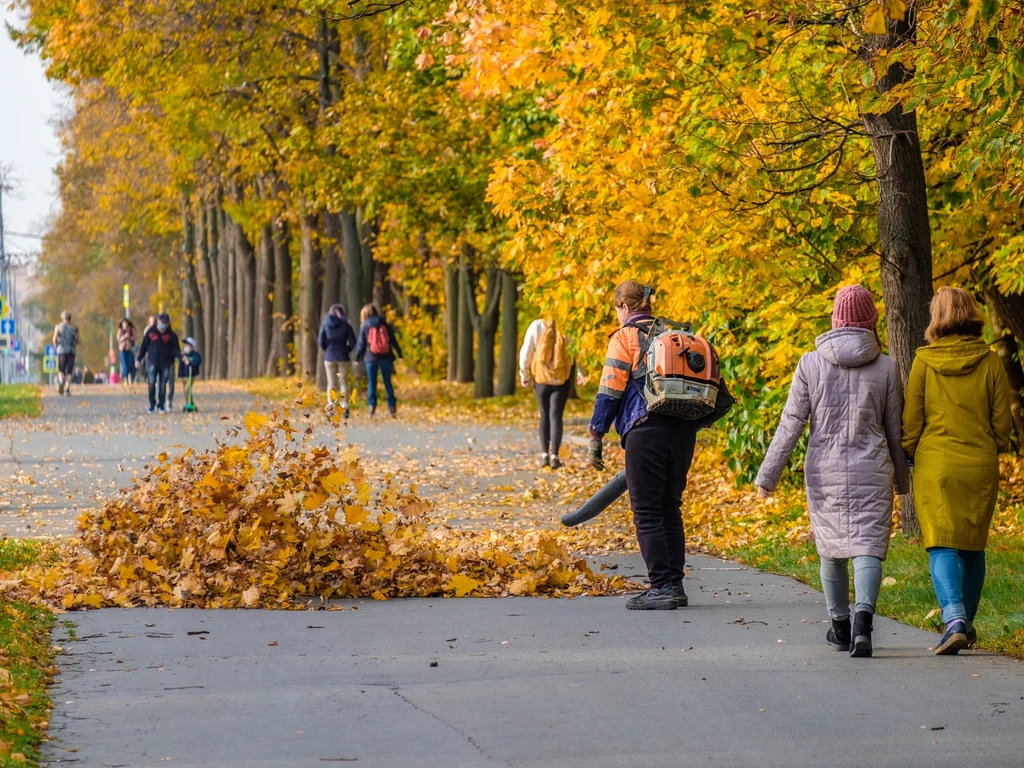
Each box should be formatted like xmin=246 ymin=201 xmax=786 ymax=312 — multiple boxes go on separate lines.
xmin=519 ymin=319 xmax=586 ymax=469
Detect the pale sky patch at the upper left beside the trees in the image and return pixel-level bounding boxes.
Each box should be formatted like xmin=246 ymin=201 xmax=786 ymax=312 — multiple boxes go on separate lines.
xmin=0 ymin=0 xmax=67 ymax=253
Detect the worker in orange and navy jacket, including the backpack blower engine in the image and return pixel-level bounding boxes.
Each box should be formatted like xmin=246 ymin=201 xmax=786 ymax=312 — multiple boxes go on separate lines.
xmin=590 ymin=281 xmax=733 ymax=610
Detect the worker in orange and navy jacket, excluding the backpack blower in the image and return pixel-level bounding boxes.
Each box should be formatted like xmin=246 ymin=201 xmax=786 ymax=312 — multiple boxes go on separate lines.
xmin=590 ymin=280 xmax=733 ymax=610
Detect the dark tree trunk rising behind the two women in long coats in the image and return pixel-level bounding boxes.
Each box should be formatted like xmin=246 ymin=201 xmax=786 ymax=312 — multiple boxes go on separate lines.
xmin=860 ymin=4 xmax=932 ymax=536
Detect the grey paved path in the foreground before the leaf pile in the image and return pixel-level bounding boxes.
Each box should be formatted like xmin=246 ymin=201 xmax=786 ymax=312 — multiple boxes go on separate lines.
xmin=45 ymin=557 xmax=1024 ymax=768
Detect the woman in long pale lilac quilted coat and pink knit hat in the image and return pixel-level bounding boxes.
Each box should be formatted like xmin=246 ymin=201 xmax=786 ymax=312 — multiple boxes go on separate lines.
xmin=757 ymin=286 xmax=909 ymax=656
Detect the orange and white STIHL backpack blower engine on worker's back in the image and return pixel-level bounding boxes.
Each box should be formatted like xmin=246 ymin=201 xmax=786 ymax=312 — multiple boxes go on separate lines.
xmin=637 ymin=317 xmax=722 ymax=421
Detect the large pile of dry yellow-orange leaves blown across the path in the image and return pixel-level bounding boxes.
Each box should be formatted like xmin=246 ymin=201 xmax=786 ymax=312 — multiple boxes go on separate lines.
xmin=0 ymin=412 xmax=626 ymax=608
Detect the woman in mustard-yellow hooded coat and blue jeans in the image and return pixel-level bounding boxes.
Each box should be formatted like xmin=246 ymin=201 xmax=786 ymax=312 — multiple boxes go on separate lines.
xmin=903 ymin=288 xmax=1013 ymax=655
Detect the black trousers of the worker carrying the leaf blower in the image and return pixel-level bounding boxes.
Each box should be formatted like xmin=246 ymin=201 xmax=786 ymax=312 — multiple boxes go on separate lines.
xmin=626 ymin=416 xmax=697 ymax=587
